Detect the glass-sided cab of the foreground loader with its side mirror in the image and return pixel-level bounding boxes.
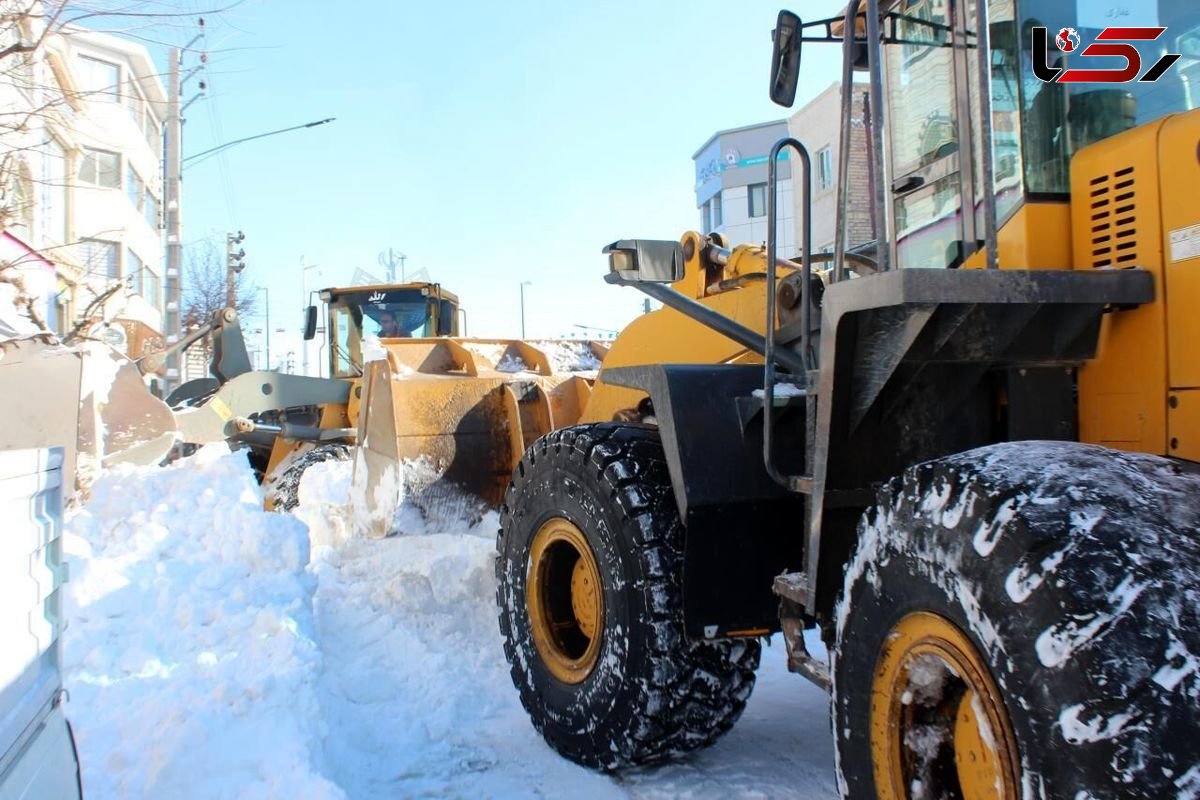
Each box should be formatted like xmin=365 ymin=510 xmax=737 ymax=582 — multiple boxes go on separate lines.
xmin=770 ymin=0 xmax=1200 ymax=269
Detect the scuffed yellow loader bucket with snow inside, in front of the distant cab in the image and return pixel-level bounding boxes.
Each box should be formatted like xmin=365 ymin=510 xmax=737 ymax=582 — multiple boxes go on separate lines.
xmin=354 ymin=338 xmax=593 ymax=536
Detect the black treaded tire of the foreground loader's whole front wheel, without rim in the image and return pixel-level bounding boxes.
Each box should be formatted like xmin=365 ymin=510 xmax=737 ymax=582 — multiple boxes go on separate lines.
xmin=496 ymin=423 xmax=760 ymax=769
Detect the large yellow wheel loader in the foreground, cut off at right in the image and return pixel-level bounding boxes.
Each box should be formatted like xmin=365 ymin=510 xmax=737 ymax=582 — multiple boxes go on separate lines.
xmin=497 ymin=0 xmax=1200 ymax=800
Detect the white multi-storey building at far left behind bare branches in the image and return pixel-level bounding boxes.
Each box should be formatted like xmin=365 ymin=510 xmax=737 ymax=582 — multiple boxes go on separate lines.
xmin=0 ymin=7 xmax=166 ymax=356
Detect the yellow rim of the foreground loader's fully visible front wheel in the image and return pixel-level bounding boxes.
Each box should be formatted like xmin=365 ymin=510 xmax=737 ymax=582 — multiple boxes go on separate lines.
xmin=526 ymin=517 xmax=604 ymax=684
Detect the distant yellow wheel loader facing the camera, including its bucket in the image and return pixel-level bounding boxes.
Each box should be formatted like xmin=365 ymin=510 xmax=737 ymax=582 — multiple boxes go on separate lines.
xmin=154 ymin=283 xmax=606 ymax=536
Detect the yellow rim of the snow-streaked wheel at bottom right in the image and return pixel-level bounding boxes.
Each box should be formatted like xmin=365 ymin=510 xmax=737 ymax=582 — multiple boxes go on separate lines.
xmin=871 ymin=612 xmax=1020 ymax=800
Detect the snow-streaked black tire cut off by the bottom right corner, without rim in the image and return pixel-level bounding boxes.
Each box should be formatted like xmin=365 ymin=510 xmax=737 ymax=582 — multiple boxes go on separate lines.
xmin=833 ymin=441 xmax=1200 ymax=800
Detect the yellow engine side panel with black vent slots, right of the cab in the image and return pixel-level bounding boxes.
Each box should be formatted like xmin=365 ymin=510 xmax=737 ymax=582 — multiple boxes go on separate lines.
xmin=1070 ymin=118 xmax=1171 ymax=455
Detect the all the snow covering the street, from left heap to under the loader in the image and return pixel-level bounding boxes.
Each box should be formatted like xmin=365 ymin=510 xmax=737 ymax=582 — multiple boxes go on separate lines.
xmin=65 ymin=447 xmax=836 ymax=799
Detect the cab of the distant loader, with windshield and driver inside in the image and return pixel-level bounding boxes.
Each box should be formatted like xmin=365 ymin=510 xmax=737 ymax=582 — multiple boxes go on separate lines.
xmin=322 ymin=283 xmax=458 ymax=378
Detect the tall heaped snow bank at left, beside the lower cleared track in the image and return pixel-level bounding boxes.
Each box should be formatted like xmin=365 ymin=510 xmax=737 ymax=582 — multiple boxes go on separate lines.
xmin=64 ymin=445 xmax=343 ymax=798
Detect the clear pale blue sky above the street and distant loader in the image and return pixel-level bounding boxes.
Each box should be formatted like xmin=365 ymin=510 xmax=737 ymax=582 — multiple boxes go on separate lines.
xmin=162 ymin=0 xmax=841 ymax=357
